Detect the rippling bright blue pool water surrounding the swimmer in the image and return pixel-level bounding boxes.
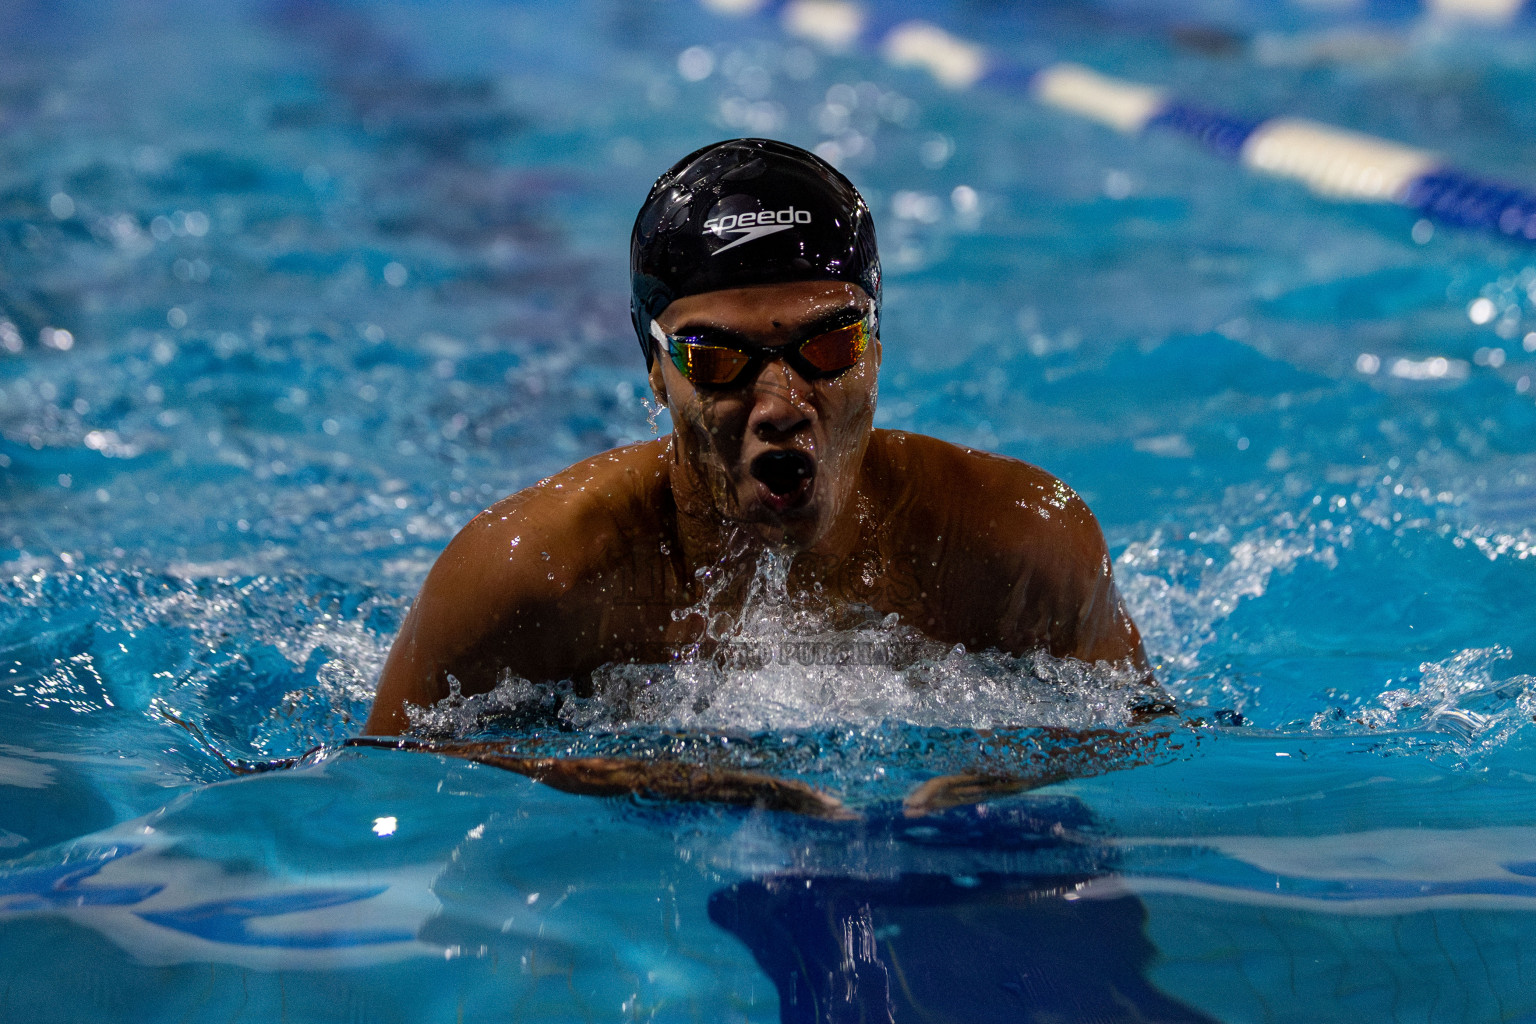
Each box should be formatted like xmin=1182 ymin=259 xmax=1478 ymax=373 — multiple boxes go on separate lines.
xmin=0 ymin=0 xmax=1536 ymax=1021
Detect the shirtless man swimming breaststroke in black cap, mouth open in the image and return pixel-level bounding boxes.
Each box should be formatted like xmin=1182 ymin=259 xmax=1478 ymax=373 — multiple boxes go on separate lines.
xmin=366 ymin=140 xmax=1150 ymax=814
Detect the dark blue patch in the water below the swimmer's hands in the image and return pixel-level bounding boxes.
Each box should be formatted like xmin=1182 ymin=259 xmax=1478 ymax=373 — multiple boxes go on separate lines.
xmin=708 ymin=800 xmax=1212 ymax=1024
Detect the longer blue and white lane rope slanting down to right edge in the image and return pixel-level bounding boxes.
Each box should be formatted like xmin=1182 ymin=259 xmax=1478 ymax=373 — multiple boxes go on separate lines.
xmin=703 ymin=0 xmax=1536 ymax=243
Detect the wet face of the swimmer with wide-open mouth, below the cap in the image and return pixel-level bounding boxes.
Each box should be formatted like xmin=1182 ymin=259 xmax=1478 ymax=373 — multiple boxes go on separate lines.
xmin=651 ymin=281 xmax=880 ymax=550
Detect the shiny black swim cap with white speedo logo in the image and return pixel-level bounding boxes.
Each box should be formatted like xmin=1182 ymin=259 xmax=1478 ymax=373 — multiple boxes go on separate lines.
xmin=630 ymin=138 xmax=880 ymax=367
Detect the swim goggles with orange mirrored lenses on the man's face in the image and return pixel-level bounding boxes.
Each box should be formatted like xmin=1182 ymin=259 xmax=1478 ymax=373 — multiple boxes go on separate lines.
xmin=651 ymin=310 xmax=876 ymax=387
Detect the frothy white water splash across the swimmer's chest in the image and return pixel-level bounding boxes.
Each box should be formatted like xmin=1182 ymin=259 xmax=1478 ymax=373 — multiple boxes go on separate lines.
xmin=412 ymin=550 xmax=1154 ymax=746
